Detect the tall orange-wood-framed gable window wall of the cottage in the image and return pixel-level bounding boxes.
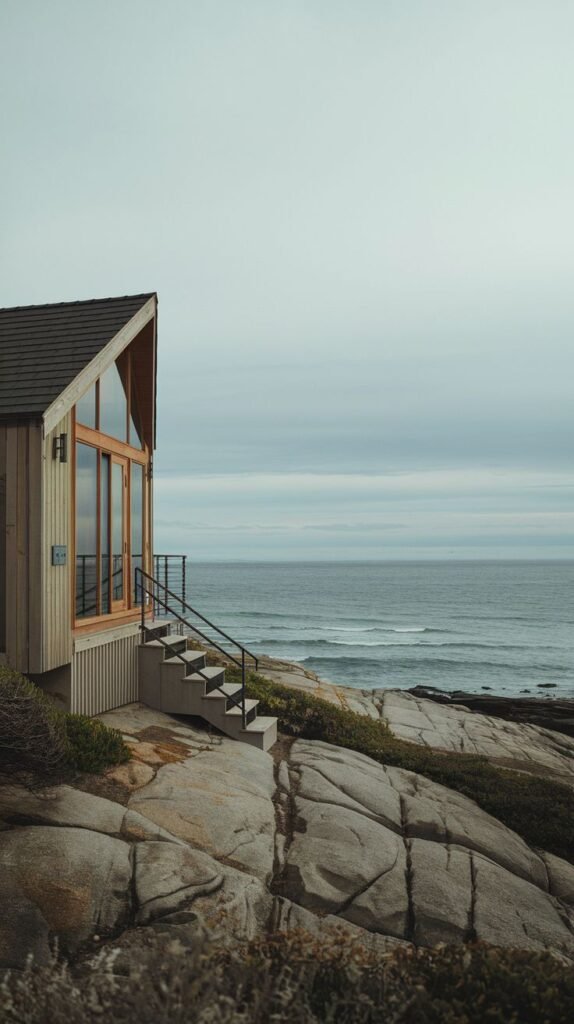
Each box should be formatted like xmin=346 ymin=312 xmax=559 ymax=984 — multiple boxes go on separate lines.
xmin=76 ymin=349 xmax=149 ymax=622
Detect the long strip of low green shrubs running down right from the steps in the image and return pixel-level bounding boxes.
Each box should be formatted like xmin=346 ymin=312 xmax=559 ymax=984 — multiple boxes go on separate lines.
xmin=233 ymin=669 xmax=574 ymax=863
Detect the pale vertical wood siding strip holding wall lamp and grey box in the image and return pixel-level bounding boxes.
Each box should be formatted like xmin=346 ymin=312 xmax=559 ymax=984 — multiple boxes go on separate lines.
xmin=42 ymin=413 xmax=74 ymax=672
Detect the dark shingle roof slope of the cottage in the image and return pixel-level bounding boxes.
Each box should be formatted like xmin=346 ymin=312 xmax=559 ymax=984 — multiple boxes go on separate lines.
xmin=0 ymin=292 xmax=154 ymax=419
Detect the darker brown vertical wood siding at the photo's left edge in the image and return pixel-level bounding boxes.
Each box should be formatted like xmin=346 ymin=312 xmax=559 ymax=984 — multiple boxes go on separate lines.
xmin=0 ymin=423 xmax=43 ymax=672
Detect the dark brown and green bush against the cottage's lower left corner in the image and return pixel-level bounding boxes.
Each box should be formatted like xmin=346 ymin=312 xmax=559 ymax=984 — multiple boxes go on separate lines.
xmin=0 ymin=666 xmax=130 ymax=785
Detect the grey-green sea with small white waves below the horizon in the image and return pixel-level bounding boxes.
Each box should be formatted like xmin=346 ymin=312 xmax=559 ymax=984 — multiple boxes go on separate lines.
xmin=188 ymin=561 xmax=574 ymax=697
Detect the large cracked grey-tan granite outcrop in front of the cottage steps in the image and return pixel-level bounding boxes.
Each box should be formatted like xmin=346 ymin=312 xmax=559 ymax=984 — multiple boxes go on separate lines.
xmin=0 ymin=706 xmax=574 ymax=967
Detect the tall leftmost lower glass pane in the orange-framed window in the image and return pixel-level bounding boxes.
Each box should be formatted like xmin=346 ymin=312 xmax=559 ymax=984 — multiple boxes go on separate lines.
xmin=76 ymin=444 xmax=97 ymax=618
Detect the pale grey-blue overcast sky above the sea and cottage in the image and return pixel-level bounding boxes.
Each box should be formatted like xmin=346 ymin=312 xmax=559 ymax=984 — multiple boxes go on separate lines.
xmin=0 ymin=0 xmax=574 ymax=559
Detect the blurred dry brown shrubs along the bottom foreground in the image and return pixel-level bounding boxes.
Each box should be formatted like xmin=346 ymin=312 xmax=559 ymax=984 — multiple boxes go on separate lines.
xmin=0 ymin=931 xmax=574 ymax=1024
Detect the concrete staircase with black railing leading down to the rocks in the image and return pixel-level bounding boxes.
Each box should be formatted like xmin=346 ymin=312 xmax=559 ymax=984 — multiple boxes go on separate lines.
xmin=136 ymin=569 xmax=277 ymax=751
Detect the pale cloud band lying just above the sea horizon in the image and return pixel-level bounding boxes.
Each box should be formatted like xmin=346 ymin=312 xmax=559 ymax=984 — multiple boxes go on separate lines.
xmin=156 ymin=469 xmax=574 ymax=558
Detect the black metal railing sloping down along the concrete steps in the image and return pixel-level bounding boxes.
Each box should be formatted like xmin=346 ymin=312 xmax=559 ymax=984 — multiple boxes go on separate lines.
xmin=135 ymin=566 xmax=259 ymax=729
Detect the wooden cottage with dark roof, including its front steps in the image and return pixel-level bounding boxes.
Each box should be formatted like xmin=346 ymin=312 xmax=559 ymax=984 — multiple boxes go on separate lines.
xmin=0 ymin=293 xmax=276 ymax=749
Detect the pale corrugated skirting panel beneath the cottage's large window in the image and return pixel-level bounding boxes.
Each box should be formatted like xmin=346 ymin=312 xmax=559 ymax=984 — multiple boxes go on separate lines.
xmin=71 ymin=633 xmax=139 ymax=715
